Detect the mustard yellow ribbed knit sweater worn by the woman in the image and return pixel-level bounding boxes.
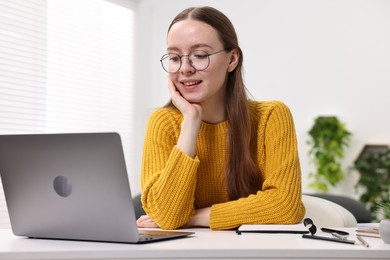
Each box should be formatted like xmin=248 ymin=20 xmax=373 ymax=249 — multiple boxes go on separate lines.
xmin=141 ymin=101 xmax=305 ymax=229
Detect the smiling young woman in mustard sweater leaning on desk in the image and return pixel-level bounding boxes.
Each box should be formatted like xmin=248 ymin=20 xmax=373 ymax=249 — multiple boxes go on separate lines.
xmin=137 ymin=7 xmax=305 ymax=229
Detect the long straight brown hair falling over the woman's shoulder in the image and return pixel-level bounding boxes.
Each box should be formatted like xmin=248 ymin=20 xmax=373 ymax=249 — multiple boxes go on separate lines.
xmin=167 ymin=7 xmax=261 ymax=200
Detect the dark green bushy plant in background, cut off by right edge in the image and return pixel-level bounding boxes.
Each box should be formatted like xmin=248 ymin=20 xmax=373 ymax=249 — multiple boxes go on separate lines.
xmin=353 ymin=149 xmax=390 ymax=220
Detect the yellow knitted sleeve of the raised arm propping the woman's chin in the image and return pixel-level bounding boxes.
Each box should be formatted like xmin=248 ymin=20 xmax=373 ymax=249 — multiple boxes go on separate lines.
xmin=141 ymin=109 xmax=199 ymax=229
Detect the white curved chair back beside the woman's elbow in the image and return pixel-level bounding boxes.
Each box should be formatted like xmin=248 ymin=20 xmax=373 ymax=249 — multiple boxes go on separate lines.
xmin=302 ymin=195 xmax=357 ymax=226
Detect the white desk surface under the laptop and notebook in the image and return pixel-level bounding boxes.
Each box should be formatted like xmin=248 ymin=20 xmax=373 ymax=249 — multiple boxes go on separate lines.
xmin=0 ymin=228 xmax=390 ymax=260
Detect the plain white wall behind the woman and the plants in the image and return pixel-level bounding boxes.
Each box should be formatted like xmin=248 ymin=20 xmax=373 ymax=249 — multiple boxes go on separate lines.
xmin=133 ymin=0 xmax=390 ymax=196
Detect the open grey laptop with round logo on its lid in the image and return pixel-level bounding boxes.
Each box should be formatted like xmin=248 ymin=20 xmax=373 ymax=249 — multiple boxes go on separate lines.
xmin=0 ymin=133 xmax=194 ymax=243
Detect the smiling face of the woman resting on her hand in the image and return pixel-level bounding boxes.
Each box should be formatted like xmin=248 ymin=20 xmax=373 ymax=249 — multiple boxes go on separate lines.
xmin=167 ymin=19 xmax=238 ymax=105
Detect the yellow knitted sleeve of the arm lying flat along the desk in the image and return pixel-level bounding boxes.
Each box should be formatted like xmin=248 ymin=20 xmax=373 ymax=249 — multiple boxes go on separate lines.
xmin=210 ymin=101 xmax=305 ymax=229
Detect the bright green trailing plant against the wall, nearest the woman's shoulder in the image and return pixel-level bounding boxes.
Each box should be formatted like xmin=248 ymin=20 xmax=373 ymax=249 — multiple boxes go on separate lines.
xmin=307 ymin=116 xmax=351 ymax=193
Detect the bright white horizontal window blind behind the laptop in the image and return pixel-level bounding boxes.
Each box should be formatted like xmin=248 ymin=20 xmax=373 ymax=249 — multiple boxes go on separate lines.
xmin=0 ymin=0 xmax=135 ymax=228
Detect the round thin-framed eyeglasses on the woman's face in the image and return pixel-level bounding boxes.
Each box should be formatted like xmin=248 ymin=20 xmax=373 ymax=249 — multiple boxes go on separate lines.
xmin=160 ymin=50 xmax=225 ymax=73
